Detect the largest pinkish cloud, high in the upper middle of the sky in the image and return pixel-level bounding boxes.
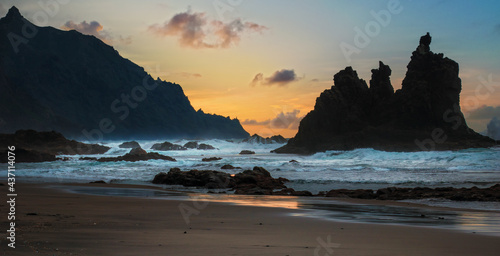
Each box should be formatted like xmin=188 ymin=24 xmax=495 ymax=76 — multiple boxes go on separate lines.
xmin=149 ymin=10 xmax=267 ymax=49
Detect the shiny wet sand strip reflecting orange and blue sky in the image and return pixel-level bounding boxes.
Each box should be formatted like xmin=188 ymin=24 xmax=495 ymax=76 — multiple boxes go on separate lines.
xmin=54 ymin=186 xmax=500 ymax=236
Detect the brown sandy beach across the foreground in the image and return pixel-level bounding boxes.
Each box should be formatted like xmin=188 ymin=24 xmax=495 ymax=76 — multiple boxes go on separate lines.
xmin=1 ymin=184 xmax=500 ymax=256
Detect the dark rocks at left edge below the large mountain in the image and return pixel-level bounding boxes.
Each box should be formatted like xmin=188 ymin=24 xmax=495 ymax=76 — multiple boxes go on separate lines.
xmin=0 ymin=130 xmax=110 ymax=161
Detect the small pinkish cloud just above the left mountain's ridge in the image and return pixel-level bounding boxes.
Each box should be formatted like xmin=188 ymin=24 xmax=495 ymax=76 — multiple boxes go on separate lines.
xmin=61 ymin=20 xmax=132 ymax=45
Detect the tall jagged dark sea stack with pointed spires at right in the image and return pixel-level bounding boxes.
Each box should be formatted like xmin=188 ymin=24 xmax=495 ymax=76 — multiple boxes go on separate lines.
xmin=273 ymin=34 xmax=496 ymax=154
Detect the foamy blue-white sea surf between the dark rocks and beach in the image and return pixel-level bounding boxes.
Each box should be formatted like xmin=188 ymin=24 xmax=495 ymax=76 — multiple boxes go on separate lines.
xmin=4 ymin=140 xmax=500 ymax=193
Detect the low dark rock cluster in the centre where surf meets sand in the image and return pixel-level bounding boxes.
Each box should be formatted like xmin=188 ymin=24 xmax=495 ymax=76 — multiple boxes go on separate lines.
xmin=152 ymin=167 xmax=288 ymax=195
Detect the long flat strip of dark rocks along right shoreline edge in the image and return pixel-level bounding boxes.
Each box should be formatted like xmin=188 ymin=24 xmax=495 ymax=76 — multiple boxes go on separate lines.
xmin=326 ymin=184 xmax=500 ymax=202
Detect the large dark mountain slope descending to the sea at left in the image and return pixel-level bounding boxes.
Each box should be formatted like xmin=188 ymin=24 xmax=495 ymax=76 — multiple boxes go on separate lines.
xmin=0 ymin=7 xmax=249 ymax=140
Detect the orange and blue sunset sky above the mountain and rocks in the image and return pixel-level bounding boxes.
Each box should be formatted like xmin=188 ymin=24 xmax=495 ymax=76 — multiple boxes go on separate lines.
xmin=0 ymin=0 xmax=500 ymax=137
